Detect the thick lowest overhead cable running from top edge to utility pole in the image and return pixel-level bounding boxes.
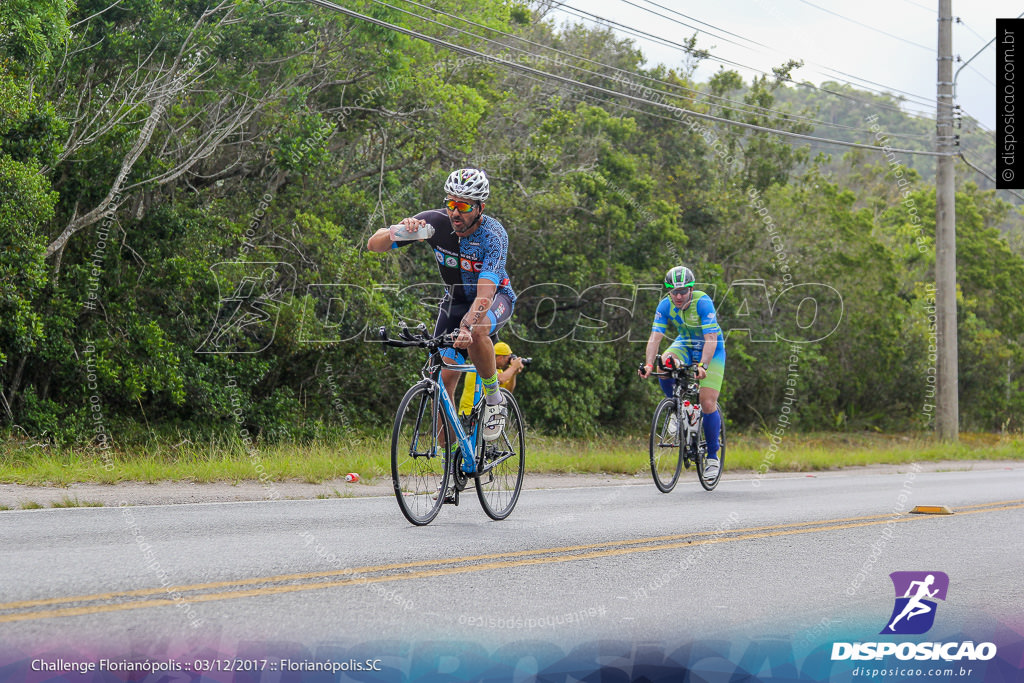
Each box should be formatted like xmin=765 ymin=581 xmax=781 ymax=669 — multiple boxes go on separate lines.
xmin=306 ymin=0 xmax=949 ymax=157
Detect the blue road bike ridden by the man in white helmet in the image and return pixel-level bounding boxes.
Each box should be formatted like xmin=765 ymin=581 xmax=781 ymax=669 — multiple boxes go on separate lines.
xmin=380 ymin=325 xmax=526 ymax=526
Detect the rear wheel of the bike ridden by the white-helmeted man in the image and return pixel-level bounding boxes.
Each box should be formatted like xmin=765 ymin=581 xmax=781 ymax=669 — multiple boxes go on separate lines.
xmin=476 ymin=389 xmax=526 ymax=519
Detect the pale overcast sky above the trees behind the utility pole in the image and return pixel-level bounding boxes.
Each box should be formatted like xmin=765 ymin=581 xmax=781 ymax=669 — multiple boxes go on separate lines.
xmin=550 ymin=0 xmax=1003 ymax=130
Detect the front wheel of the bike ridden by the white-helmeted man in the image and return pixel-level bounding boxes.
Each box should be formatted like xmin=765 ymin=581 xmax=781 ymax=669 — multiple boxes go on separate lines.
xmin=391 ymin=383 xmax=452 ymax=526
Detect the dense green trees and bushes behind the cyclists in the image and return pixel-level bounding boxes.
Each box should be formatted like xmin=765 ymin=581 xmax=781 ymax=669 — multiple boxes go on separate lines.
xmin=0 ymin=0 xmax=1024 ymax=445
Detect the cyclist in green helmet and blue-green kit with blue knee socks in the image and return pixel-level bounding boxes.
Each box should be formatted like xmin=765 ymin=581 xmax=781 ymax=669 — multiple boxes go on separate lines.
xmin=640 ymin=265 xmax=725 ymax=478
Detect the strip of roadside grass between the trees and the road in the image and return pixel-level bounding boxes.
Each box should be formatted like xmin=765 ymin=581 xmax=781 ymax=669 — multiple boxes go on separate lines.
xmin=0 ymin=433 xmax=1024 ymax=485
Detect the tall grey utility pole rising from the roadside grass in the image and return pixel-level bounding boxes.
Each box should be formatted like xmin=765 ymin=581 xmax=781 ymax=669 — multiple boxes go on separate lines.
xmin=935 ymin=0 xmax=959 ymax=441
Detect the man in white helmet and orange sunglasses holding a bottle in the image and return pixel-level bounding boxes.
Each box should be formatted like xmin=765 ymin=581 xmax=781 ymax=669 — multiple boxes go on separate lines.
xmin=367 ymin=168 xmax=515 ymax=440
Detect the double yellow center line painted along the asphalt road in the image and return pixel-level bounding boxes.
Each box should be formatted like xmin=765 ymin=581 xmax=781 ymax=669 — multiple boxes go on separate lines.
xmin=0 ymin=500 xmax=1024 ymax=624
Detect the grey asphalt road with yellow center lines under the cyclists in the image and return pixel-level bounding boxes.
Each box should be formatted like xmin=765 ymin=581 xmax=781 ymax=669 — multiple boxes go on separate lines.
xmin=0 ymin=464 xmax=1024 ymax=675
